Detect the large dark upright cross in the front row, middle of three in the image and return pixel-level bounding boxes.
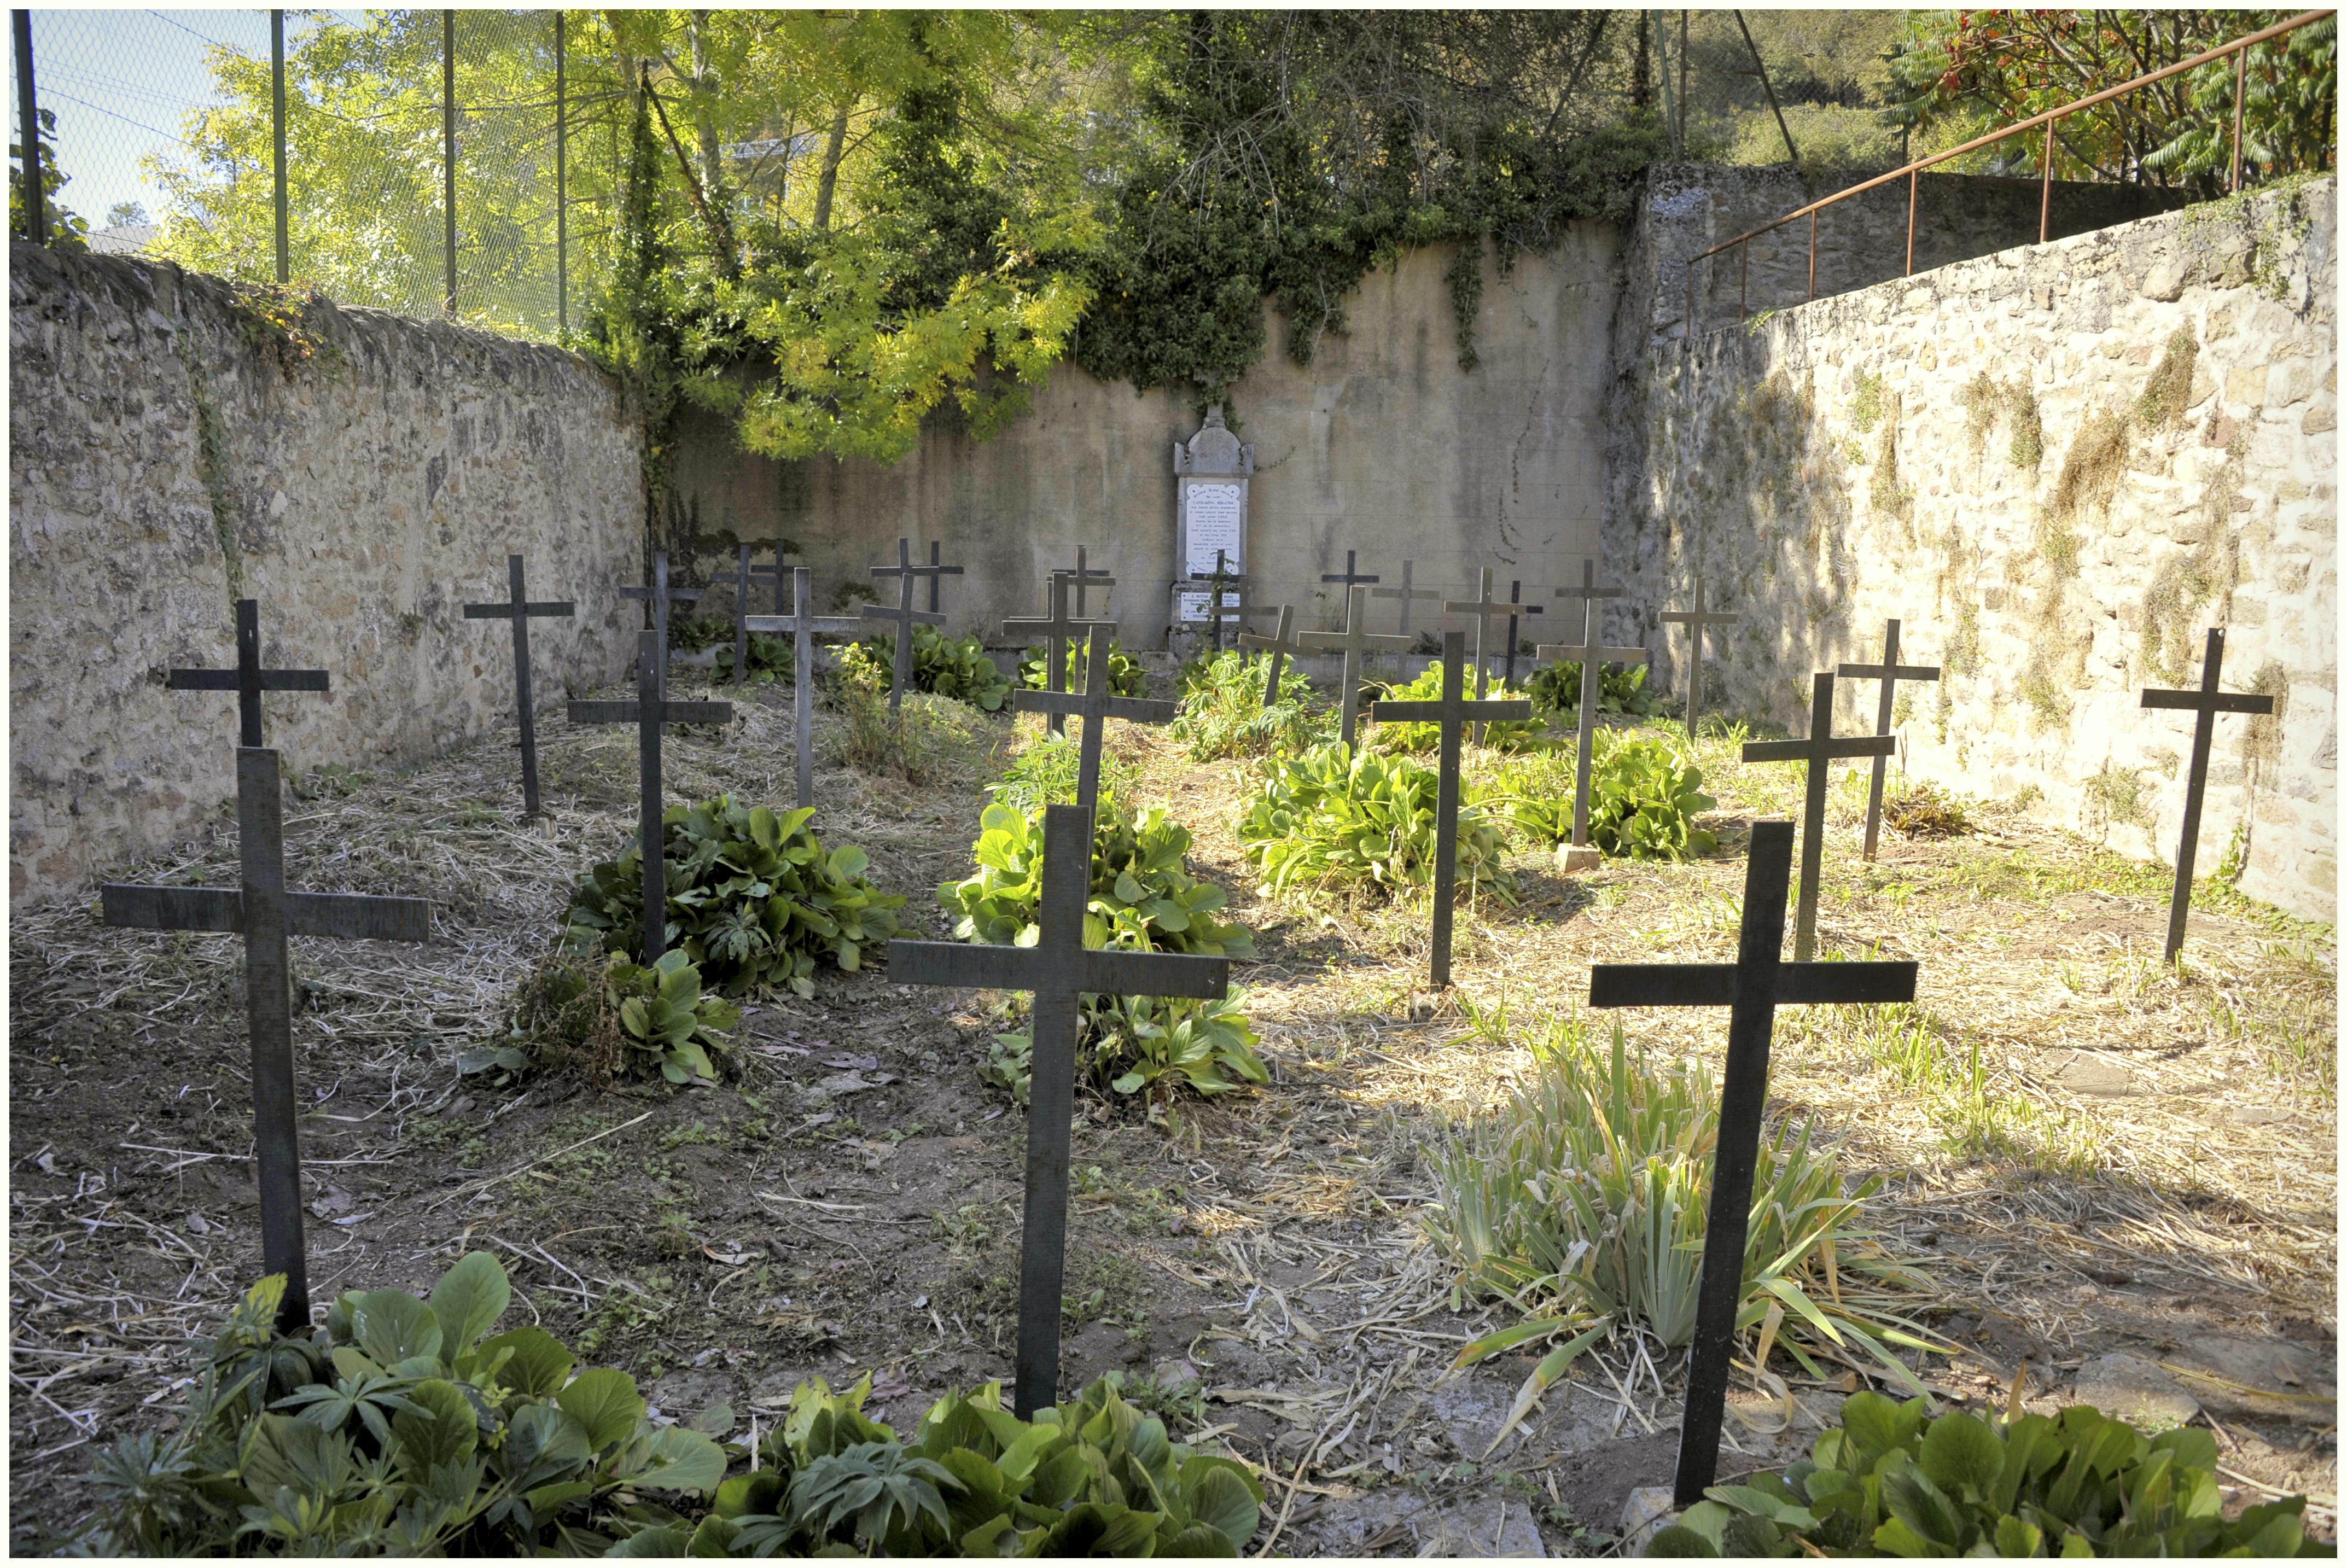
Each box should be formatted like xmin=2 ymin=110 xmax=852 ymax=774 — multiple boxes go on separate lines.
xmin=887 ymin=805 xmax=1230 ymax=1418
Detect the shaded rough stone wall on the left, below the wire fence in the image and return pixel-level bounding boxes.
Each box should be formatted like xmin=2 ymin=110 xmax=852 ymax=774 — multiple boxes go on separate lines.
xmin=9 ymin=244 xmax=643 ymax=908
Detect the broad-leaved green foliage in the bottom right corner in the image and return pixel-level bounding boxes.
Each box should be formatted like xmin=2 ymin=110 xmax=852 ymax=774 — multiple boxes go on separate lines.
xmin=1647 ymin=1392 xmax=2333 ymax=1557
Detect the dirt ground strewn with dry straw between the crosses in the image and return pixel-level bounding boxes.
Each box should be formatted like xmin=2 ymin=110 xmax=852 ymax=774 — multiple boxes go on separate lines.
xmin=9 ymin=666 xmax=2338 ymax=1554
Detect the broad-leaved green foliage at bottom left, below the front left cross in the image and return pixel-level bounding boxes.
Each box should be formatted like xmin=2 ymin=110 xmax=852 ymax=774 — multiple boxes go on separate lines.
xmin=82 ymin=1254 xmax=725 ymax=1557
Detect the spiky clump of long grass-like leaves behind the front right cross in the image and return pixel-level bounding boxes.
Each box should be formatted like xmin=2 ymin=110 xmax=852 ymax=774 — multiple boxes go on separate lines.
xmin=1427 ymin=1016 xmax=1943 ymax=1430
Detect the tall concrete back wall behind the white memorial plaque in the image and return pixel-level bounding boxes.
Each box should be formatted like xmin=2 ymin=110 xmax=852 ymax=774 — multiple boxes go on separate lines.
xmin=657 ymin=223 xmax=1615 ymax=648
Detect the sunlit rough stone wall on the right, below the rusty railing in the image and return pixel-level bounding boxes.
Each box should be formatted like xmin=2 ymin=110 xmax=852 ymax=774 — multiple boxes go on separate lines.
xmin=1605 ymin=178 xmax=2338 ymax=920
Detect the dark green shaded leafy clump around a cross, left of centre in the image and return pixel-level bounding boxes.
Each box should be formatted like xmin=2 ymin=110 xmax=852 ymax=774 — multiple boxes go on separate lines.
xmin=563 ymin=796 xmax=904 ymax=995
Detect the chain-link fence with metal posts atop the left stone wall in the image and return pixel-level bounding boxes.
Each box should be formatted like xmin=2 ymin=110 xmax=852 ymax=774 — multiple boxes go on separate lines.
xmin=14 ymin=9 xmax=624 ymax=338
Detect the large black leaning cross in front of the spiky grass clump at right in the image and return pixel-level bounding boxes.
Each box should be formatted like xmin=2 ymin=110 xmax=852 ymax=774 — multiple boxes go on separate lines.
xmin=1589 ymin=817 xmax=1915 ymax=1507
